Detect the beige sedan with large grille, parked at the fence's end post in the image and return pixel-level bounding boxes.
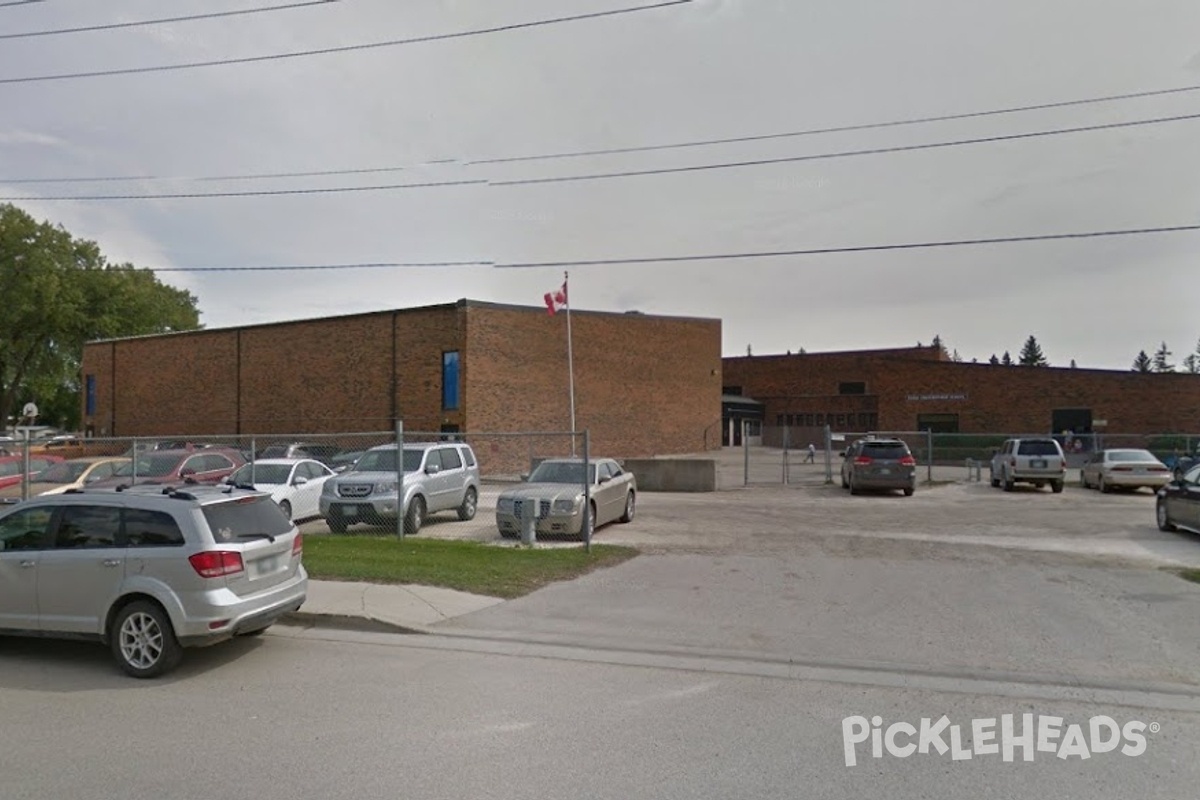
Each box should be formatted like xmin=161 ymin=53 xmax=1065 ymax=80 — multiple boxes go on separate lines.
xmin=496 ymin=458 xmax=637 ymax=539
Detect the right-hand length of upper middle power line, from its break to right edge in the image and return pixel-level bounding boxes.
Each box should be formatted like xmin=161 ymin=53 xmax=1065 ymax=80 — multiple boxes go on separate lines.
xmin=466 ymin=85 xmax=1200 ymax=166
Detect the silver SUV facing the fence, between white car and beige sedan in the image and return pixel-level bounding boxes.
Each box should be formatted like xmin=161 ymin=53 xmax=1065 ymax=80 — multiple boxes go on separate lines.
xmin=320 ymin=441 xmax=479 ymax=534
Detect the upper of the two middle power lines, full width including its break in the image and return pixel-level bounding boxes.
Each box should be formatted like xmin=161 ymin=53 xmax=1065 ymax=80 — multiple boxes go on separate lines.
xmin=0 ymin=85 xmax=1200 ymax=184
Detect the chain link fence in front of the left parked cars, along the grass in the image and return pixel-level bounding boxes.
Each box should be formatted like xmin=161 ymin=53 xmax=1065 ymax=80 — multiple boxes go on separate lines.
xmin=0 ymin=427 xmax=600 ymax=551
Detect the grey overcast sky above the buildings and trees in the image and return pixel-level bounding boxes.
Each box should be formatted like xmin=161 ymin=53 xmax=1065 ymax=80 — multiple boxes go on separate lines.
xmin=0 ymin=0 xmax=1200 ymax=369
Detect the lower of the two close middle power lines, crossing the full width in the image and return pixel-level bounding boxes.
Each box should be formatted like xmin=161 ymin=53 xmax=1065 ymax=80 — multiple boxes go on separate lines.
xmin=7 ymin=113 xmax=1200 ymax=201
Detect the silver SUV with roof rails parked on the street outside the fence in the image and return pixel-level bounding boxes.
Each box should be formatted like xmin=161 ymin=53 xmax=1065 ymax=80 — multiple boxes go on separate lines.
xmin=0 ymin=486 xmax=308 ymax=678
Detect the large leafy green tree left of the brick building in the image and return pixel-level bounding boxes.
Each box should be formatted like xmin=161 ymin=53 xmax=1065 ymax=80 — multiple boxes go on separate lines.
xmin=0 ymin=205 xmax=200 ymax=428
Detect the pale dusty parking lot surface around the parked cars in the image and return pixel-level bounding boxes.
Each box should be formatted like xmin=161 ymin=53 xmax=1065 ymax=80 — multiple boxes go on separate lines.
xmin=302 ymin=455 xmax=1200 ymax=567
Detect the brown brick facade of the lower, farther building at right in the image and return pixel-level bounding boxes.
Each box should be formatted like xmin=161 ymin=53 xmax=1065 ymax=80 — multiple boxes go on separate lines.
xmin=724 ymin=349 xmax=1200 ymax=434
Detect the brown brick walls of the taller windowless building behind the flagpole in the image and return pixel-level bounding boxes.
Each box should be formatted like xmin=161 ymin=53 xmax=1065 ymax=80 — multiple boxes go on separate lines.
xmin=83 ymin=301 xmax=721 ymax=457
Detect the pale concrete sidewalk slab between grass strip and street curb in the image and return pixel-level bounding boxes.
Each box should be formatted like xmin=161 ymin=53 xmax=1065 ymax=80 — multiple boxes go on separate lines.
xmin=287 ymin=579 xmax=504 ymax=633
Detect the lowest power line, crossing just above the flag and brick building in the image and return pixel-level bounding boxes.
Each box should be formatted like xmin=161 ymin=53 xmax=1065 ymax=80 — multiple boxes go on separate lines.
xmin=138 ymin=224 xmax=1200 ymax=272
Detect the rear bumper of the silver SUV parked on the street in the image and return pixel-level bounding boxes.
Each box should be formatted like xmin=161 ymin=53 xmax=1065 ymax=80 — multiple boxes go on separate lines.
xmin=173 ymin=566 xmax=308 ymax=648
